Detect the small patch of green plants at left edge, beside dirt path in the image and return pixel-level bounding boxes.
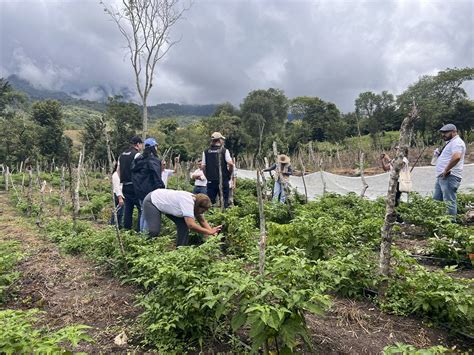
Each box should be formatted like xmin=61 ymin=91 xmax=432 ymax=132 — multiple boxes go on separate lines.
xmin=0 ymin=240 xmax=24 ymax=304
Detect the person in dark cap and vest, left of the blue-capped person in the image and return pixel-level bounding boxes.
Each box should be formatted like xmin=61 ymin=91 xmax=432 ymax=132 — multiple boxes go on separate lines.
xmin=117 ymin=136 xmax=143 ymax=231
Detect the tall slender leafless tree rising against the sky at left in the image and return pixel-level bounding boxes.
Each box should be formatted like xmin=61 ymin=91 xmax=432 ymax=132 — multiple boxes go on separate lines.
xmin=101 ymin=0 xmax=188 ymax=139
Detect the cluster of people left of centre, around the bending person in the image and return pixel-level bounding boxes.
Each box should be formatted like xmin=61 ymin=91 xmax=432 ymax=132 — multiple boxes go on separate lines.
xmin=111 ymin=132 xmax=236 ymax=246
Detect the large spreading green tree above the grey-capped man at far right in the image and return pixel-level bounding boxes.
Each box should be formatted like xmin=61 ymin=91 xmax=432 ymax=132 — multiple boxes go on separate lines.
xmin=397 ymin=68 xmax=474 ymax=143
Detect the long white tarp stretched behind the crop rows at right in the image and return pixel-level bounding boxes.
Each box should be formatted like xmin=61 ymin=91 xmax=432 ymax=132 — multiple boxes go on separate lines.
xmin=237 ymin=164 xmax=474 ymax=199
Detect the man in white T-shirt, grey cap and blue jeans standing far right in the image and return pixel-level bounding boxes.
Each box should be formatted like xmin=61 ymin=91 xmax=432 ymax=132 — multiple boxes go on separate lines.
xmin=433 ymin=123 xmax=466 ymax=220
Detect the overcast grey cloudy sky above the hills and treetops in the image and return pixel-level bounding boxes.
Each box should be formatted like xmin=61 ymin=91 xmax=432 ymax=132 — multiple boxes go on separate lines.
xmin=0 ymin=0 xmax=474 ymax=112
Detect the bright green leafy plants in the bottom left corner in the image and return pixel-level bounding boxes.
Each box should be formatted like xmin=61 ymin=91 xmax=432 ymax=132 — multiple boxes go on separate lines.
xmin=0 ymin=309 xmax=92 ymax=354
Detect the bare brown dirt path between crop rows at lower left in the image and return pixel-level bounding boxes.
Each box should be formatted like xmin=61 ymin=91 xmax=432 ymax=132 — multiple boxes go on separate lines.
xmin=0 ymin=193 xmax=140 ymax=353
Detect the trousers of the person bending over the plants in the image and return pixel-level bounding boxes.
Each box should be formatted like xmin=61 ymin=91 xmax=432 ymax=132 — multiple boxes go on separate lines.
xmin=143 ymin=194 xmax=189 ymax=247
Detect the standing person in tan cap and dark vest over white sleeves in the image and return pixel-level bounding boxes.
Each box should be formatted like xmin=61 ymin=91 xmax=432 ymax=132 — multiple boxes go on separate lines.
xmin=202 ymin=132 xmax=234 ymax=208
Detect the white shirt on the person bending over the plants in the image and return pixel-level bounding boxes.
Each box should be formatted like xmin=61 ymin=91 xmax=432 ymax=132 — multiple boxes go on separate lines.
xmin=151 ymin=189 xmax=194 ymax=218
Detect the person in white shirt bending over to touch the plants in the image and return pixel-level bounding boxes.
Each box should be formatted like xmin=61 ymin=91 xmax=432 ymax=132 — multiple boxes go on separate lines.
xmin=143 ymin=189 xmax=222 ymax=246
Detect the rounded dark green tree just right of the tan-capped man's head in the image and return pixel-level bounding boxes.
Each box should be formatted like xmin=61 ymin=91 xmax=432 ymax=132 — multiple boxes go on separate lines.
xmin=240 ymin=88 xmax=288 ymax=152
